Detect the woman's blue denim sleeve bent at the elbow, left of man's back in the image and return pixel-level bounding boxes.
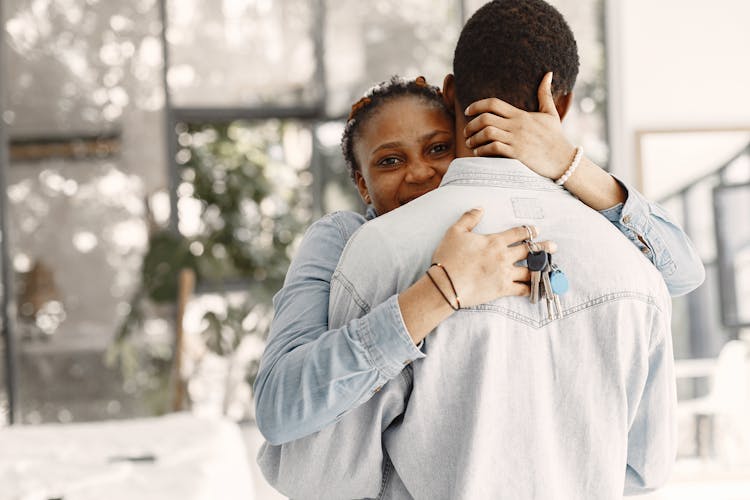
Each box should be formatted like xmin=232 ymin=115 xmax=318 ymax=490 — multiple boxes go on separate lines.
xmin=254 ymin=212 xmax=424 ymax=444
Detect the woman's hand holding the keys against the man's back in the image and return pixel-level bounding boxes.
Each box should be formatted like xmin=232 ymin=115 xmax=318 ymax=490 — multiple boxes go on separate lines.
xmin=430 ymin=208 xmax=557 ymax=307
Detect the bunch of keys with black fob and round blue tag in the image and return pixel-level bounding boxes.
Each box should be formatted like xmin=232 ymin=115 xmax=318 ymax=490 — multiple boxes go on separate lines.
xmin=526 ymin=242 xmax=569 ymax=319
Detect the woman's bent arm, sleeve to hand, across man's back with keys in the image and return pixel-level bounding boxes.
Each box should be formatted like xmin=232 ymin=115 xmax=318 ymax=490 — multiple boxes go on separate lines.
xmin=254 ymin=209 xmax=554 ymax=444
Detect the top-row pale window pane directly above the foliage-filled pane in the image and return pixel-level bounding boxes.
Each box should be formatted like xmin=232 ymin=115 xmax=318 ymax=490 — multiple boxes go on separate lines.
xmin=167 ymin=0 xmax=321 ymax=107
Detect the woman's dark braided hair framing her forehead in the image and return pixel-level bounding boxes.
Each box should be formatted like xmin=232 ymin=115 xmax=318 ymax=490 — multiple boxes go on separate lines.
xmin=341 ymin=76 xmax=452 ymax=182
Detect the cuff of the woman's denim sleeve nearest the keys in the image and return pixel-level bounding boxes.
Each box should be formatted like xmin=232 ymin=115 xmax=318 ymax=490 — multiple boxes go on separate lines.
xmin=358 ymin=295 xmax=425 ymax=380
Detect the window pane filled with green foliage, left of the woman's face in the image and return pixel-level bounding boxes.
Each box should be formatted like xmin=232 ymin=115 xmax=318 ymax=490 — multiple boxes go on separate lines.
xmin=177 ymin=120 xmax=313 ymax=288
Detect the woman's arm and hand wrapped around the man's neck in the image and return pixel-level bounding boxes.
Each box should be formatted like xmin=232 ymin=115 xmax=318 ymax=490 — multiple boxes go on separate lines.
xmin=465 ymin=73 xmax=705 ymax=296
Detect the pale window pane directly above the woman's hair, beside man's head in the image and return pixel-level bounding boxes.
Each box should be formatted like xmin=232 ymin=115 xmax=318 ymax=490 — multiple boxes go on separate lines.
xmin=325 ymin=0 xmax=461 ymax=116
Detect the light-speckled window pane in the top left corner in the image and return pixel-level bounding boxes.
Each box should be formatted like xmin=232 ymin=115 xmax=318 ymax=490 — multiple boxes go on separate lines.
xmin=3 ymin=0 xmax=164 ymax=137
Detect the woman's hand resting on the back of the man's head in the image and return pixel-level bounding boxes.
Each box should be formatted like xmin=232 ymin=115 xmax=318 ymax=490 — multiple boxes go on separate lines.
xmin=464 ymin=72 xmax=575 ymax=180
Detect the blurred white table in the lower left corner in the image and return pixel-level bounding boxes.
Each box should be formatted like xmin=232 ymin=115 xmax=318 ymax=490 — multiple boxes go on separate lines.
xmin=0 ymin=413 xmax=253 ymax=500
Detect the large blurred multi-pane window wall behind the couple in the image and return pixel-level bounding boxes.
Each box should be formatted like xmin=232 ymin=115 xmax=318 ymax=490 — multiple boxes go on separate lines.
xmin=0 ymin=0 xmax=607 ymax=423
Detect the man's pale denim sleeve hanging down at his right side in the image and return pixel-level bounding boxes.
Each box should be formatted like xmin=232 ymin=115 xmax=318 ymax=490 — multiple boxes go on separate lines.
xmin=624 ymin=304 xmax=677 ymax=495
